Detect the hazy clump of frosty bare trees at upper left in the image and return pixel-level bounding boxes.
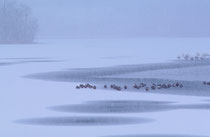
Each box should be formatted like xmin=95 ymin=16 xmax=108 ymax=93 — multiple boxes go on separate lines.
xmin=0 ymin=0 xmax=38 ymax=43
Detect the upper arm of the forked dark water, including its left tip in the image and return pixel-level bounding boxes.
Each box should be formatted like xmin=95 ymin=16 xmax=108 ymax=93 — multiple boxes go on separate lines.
xmin=28 ymin=61 xmax=210 ymax=80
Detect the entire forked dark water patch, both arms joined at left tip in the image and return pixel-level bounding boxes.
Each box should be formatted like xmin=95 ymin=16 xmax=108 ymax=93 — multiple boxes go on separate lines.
xmin=25 ymin=61 xmax=210 ymax=96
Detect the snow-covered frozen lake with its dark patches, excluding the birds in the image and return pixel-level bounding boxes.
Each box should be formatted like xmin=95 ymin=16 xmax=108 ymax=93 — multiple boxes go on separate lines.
xmin=0 ymin=38 xmax=210 ymax=137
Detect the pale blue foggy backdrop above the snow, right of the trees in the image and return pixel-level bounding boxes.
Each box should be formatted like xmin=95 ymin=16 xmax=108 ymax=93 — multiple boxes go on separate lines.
xmin=18 ymin=0 xmax=210 ymax=37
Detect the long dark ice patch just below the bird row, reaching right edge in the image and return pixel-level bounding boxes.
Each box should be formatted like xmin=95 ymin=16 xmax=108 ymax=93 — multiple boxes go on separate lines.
xmin=49 ymin=100 xmax=210 ymax=113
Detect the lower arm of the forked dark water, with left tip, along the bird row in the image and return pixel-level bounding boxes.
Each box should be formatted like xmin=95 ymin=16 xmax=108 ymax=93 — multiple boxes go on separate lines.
xmin=26 ymin=71 xmax=210 ymax=96
